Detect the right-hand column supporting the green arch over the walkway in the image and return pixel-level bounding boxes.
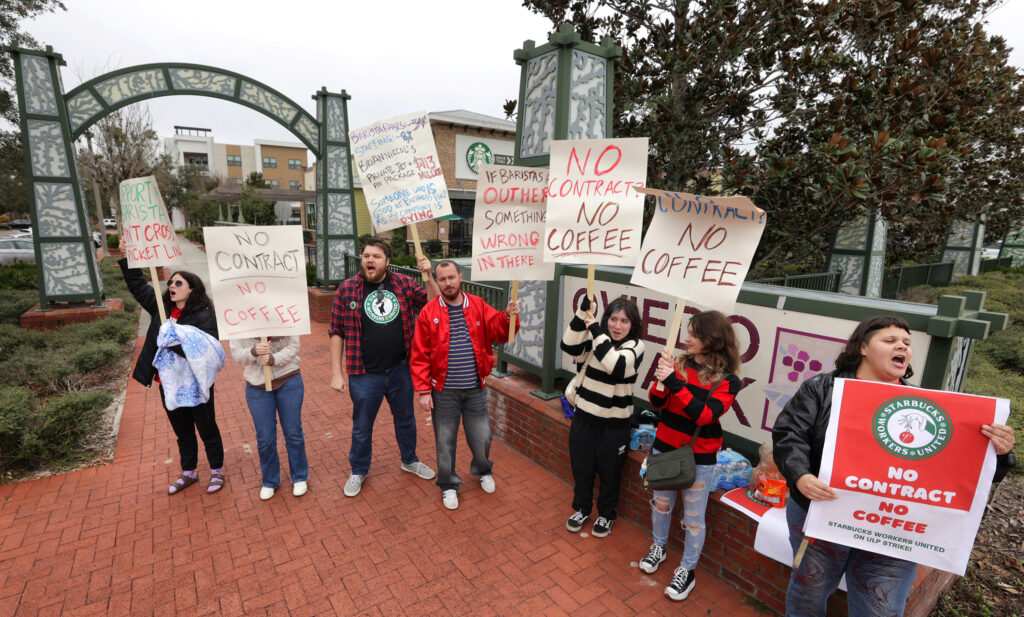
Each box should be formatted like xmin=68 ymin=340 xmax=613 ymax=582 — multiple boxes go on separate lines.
xmin=313 ymin=88 xmax=356 ymax=283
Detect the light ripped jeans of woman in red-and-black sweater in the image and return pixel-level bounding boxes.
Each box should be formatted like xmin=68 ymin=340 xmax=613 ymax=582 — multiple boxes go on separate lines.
xmin=650 ymin=465 xmax=715 ymax=571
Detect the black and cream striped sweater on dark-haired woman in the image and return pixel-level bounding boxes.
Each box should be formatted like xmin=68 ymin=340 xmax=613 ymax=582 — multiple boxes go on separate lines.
xmin=562 ymin=310 xmax=644 ymax=417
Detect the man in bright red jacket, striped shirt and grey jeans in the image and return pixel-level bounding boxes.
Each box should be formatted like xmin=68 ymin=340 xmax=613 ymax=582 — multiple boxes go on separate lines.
xmin=410 ymin=260 xmax=519 ymax=510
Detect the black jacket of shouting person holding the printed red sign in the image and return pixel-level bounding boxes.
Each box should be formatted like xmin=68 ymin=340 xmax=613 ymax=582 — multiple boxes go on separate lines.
xmin=771 ymin=372 xmax=1011 ymax=509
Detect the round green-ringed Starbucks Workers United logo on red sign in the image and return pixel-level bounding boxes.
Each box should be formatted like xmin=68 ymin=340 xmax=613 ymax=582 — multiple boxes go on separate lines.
xmin=871 ymin=396 xmax=953 ymax=460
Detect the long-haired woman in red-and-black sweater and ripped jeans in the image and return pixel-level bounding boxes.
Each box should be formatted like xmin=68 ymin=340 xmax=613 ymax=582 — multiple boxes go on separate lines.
xmin=640 ymin=311 xmax=742 ymax=601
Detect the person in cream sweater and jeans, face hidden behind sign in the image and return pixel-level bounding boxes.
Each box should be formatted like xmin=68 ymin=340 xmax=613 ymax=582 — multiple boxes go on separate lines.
xmin=231 ymin=337 xmax=309 ymax=501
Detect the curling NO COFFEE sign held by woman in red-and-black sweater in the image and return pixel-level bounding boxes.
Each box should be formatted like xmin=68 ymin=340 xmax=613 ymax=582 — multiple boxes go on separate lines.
xmin=630 ymin=188 xmax=767 ymax=312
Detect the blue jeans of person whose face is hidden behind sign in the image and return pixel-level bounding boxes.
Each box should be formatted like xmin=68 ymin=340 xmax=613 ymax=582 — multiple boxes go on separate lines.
xmin=246 ymin=374 xmax=309 ymax=488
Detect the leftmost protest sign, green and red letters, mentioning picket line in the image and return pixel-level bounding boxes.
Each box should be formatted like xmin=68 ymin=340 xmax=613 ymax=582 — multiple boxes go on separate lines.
xmin=120 ymin=176 xmax=181 ymax=268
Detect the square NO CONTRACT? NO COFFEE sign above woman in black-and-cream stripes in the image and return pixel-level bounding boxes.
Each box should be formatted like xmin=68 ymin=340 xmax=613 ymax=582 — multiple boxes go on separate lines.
xmin=544 ymin=137 xmax=647 ymax=266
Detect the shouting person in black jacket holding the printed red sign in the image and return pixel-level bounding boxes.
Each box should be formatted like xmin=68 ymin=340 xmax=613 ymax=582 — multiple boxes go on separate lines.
xmin=772 ymin=317 xmax=1014 ymax=617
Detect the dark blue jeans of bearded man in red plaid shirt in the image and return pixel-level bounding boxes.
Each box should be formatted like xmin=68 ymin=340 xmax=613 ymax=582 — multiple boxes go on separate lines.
xmin=348 ymin=362 xmax=419 ymax=476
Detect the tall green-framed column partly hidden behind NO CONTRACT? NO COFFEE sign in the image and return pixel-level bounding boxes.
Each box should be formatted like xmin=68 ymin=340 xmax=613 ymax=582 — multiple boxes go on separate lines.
xmin=502 ymin=24 xmax=622 ymax=399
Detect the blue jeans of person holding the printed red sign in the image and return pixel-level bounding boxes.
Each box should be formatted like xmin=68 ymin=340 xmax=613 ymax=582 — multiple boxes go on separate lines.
xmin=785 ymin=499 xmax=916 ymax=617
